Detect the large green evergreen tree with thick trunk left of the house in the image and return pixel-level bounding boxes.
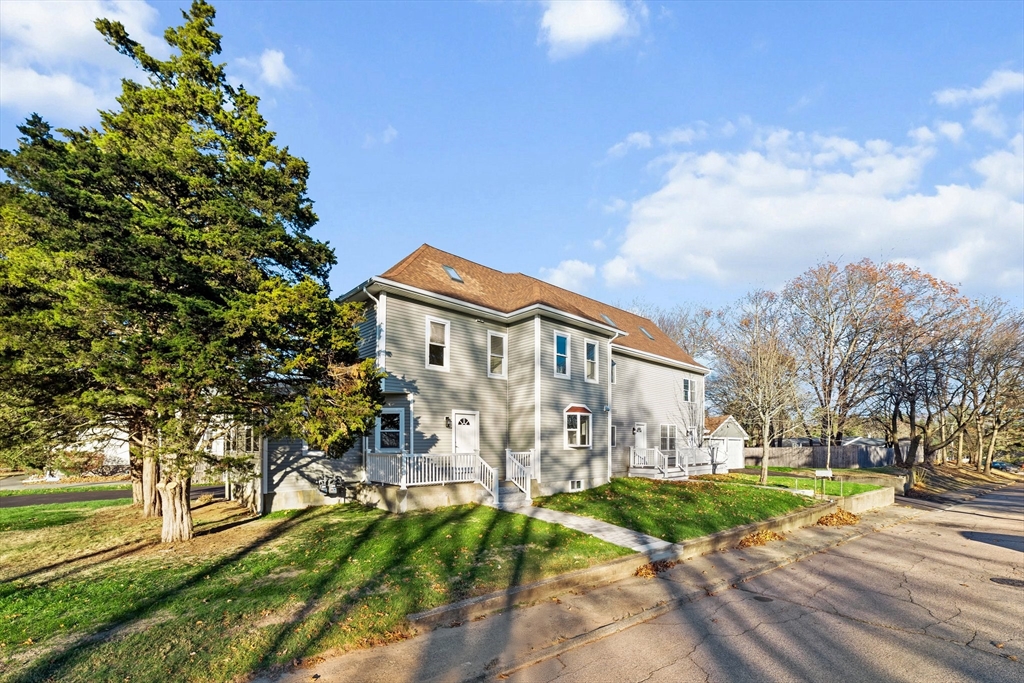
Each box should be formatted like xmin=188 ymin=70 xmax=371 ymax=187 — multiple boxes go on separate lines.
xmin=0 ymin=0 xmax=381 ymax=542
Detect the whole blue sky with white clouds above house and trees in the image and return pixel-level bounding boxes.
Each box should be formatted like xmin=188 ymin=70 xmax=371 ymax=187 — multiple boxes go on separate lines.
xmin=0 ymin=0 xmax=1024 ymax=306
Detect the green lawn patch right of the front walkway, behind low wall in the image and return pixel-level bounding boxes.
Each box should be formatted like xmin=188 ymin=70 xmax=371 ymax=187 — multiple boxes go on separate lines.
xmin=534 ymin=477 xmax=814 ymax=543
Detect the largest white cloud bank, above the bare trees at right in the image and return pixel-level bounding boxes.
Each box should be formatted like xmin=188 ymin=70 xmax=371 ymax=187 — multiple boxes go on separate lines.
xmin=601 ymin=127 xmax=1024 ymax=296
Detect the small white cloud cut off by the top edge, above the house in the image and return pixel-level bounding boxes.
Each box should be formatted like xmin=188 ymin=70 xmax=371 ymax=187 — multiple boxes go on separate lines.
xmin=539 ymin=0 xmax=647 ymax=59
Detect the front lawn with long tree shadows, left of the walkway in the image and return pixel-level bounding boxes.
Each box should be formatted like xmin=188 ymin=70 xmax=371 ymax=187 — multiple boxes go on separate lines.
xmin=0 ymin=501 xmax=630 ymax=683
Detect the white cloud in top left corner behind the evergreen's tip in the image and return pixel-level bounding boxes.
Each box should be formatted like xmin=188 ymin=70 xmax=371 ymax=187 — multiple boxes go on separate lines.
xmin=0 ymin=0 xmax=162 ymax=125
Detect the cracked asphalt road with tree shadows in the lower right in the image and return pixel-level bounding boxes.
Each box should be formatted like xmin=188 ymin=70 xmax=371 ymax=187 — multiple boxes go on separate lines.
xmin=509 ymin=484 xmax=1024 ymax=683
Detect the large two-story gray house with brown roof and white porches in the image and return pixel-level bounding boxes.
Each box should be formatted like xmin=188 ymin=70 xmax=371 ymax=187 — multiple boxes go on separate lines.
xmin=260 ymin=245 xmax=716 ymax=511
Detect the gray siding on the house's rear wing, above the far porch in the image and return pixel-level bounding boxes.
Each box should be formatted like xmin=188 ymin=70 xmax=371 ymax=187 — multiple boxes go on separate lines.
xmin=611 ymin=353 xmax=703 ymax=476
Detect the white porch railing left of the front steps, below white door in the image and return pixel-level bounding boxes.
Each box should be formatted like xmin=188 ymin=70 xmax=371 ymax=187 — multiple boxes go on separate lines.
xmin=366 ymin=453 xmax=498 ymax=505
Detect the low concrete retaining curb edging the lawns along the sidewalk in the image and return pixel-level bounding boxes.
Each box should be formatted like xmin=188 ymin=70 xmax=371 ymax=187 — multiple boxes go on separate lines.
xmin=408 ymin=501 xmax=836 ymax=629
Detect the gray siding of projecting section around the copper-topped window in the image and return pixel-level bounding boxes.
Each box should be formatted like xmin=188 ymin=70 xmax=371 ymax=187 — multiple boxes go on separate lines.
xmin=540 ymin=317 xmax=608 ymax=492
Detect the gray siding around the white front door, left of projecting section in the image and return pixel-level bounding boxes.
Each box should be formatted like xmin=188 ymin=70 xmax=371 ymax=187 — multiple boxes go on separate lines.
xmin=385 ymin=295 xmax=509 ymax=474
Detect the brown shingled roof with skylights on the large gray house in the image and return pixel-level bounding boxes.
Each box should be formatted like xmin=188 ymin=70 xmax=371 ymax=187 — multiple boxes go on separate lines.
xmin=381 ymin=245 xmax=702 ymax=368
